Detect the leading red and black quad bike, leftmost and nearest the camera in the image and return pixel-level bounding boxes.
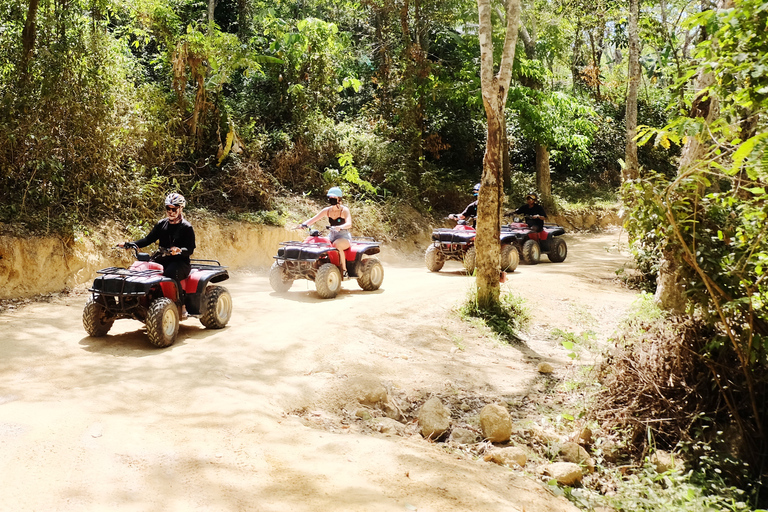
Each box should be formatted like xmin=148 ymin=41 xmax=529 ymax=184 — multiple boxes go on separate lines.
xmin=83 ymin=243 xmax=232 ymax=348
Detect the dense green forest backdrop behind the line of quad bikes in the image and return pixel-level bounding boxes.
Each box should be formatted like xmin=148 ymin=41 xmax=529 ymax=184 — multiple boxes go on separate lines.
xmin=0 ymin=0 xmax=671 ymax=231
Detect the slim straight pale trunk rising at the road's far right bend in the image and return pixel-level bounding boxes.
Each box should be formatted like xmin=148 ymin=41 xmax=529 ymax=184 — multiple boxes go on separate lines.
xmin=621 ymin=0 xmax=640 ymax=181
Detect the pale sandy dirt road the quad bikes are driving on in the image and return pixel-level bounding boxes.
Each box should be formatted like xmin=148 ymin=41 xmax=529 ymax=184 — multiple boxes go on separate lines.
xmin=0 ymin=233 xmax=635 ymax=512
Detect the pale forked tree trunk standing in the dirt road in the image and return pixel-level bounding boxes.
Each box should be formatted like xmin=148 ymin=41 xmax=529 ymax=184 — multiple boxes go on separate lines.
xmin=475 ymin=0 xmax=520 ymax=309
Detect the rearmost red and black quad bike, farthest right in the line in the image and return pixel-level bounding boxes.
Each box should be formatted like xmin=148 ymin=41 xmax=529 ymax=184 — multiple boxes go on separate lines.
xmin=501 ymin=217 xmax=568 ymax=265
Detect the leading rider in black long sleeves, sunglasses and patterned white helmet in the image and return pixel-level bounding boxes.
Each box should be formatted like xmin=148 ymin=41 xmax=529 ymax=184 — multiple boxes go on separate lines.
xmin=117 ymin=193 xmax=195 ymax=282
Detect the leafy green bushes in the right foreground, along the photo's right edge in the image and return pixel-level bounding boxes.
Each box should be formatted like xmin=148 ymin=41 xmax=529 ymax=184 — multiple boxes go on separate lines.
xmin=624 ymin=0 xmax=768 ymax=499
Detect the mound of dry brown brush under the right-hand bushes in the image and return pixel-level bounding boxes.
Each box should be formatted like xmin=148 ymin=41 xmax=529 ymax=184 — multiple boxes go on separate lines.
xmin=593 ymin=319 xmax=722 ymax=458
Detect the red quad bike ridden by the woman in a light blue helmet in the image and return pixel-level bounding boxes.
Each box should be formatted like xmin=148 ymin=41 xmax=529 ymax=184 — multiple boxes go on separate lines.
xmin=269 ymin=229 xmax=384 ymax=299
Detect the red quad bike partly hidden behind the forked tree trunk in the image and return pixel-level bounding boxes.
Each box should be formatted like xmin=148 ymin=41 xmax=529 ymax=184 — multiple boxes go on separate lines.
xmin=424 ymin=217 xmax=520 ymax=274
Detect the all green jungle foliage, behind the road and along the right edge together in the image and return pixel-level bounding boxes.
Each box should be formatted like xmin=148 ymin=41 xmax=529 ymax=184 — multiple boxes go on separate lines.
xmin=0 ymin=0 xmax=768 ymax=504
